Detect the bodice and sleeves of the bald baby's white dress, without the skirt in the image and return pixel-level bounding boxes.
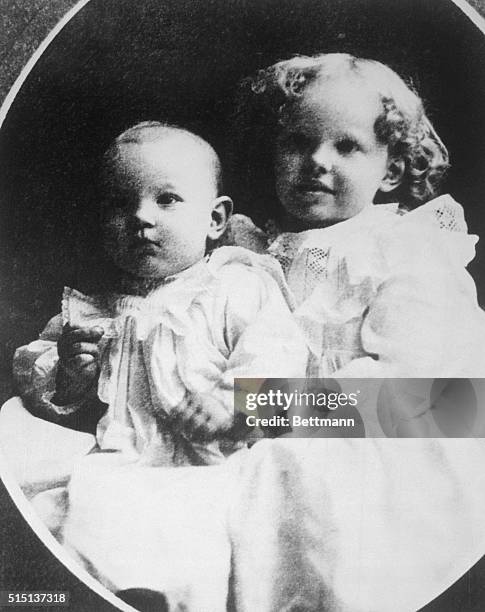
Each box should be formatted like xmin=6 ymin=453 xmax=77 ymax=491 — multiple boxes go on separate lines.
xmin=10 ymin=247 xmax=308 ymax=465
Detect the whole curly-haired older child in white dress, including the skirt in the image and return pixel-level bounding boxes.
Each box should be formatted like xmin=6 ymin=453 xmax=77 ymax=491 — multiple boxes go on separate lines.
xmin=229 ymin=54 xmax=485 ymax=612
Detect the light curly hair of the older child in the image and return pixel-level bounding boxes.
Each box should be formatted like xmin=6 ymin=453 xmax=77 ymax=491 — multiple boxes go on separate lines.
xmin=234 ymin=53 xmax=449 ymax=218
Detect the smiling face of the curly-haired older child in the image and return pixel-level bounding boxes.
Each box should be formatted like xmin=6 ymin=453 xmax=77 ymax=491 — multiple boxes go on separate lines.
xmin=275 ymin=77 xmax=389 ymax=228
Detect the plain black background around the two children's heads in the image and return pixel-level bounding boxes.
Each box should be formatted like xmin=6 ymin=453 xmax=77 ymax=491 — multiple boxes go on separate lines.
xmin=0 ymin=0 xmax=485 ymax=611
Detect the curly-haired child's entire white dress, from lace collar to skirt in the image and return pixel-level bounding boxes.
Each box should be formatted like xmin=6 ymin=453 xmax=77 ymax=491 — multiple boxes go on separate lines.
xmin=224 ymin=197 xmax=485 ymax=612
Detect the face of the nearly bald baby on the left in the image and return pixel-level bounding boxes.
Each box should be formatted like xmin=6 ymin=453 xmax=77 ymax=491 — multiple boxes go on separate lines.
xmin=103 ymin=131 xmax=217 ymax=278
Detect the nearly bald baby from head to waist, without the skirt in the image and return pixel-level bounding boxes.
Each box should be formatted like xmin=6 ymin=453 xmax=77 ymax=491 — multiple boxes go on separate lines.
xmin=14 ymin=122 xmax=307 ymax=466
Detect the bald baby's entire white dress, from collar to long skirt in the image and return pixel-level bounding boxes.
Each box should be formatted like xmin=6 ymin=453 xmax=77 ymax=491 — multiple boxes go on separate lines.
xmin=0 ymin=247 xmax=308 ymax=612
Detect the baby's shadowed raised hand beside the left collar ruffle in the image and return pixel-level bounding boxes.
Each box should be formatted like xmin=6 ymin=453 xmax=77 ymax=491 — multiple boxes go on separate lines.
xmin=53 ymin=325 xmax=104 ymax=405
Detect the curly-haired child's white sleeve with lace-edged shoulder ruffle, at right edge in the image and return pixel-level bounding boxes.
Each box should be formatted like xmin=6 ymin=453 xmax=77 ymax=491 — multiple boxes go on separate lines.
xmin=337 ymin=197 xmax=485 ymax=377
